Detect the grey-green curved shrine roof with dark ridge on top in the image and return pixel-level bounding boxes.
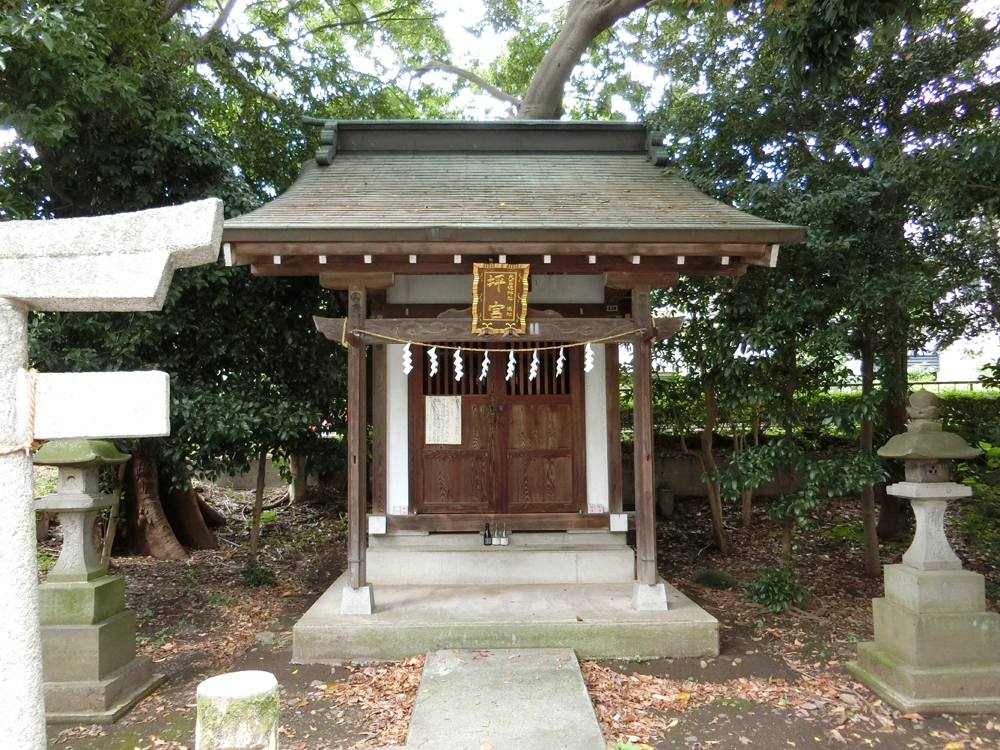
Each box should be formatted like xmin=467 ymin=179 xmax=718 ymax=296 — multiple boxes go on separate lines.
xmin=224 ymin=121 xmax=804 ymax=244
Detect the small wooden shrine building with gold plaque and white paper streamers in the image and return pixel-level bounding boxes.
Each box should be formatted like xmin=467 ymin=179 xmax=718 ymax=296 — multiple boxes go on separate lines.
xmin=223 ymin=121 xmax=804 ymax=661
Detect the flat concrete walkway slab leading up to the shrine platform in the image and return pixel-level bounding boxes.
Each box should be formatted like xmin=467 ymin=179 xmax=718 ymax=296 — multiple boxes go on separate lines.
xmin=406 ymin=648 xmax=605 ymax=750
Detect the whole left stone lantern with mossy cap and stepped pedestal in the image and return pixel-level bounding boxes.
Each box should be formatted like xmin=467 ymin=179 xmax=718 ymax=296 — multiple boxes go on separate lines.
xmin=34 ymin=440 xmax=164 ymax=723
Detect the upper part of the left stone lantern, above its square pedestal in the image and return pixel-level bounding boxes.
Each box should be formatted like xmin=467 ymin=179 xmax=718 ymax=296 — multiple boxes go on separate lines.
xmin=33 ymin=440 xmax=131 ymax=583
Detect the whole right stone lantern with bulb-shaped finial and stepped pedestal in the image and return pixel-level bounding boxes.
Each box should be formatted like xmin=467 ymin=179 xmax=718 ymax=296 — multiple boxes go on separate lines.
xmin=847 ymin=391 xmax=1000 ymax=713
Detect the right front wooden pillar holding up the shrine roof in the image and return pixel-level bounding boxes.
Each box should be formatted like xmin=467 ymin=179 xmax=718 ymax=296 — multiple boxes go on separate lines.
xmin=632 ymin=286 xmax=656 ymax=586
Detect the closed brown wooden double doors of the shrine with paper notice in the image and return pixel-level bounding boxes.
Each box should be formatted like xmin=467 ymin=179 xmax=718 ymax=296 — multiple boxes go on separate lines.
xmin=410 ymin=342 xmax=586 ymax=513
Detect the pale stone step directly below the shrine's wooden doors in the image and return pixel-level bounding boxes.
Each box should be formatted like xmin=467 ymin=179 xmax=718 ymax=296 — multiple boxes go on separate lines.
xmin=367 ymin=542 xmax=635 ymax=586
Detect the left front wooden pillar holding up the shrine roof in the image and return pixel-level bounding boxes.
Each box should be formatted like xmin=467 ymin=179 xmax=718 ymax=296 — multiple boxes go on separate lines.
xmin=347 ymin=286 xmax=368 ymax=589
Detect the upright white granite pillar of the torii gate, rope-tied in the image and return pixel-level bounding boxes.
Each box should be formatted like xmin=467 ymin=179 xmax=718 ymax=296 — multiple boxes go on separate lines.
xmin=0 ymin=297 xmax=45 ymax=750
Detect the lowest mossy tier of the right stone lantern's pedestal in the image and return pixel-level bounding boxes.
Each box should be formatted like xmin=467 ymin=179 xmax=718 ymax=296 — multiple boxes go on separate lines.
xmin=845 ymin=643 xmax=1000 ymax=715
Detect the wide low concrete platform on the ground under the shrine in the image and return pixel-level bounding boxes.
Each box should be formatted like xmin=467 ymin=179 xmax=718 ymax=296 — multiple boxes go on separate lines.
xmin=292 ymin=574 xmax=719 ymax=664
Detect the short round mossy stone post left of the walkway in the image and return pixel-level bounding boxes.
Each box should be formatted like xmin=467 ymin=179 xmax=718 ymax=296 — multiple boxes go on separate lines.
xmin=194 ymin=671 xmax=278 ymax=750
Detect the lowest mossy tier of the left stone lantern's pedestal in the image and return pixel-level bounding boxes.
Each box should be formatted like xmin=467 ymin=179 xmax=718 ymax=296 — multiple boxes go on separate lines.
xmin=44 ymin=657 xmax=167 ymax=724
